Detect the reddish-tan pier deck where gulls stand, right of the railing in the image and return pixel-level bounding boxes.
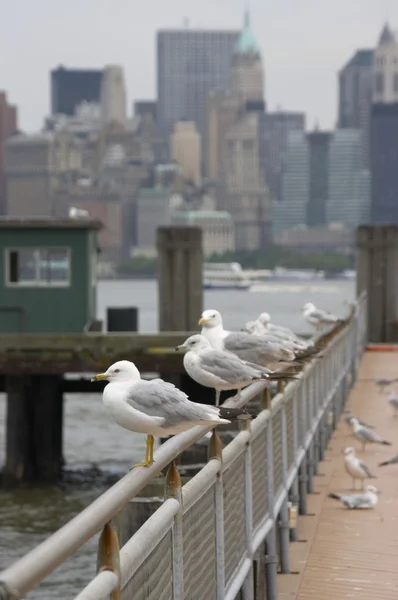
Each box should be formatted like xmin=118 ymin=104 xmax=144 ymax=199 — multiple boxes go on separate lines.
xmin=278 ymin=352 xmax=398 ymax=600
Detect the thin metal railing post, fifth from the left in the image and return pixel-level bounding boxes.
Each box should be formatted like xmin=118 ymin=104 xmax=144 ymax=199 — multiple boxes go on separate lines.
xmin=265 ymin=416 xmax=278 ymax=600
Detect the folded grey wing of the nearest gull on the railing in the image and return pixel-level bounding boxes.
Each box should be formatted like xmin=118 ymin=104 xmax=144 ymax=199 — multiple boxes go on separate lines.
xmin=126 ymin=379 xmax=215 ymax=427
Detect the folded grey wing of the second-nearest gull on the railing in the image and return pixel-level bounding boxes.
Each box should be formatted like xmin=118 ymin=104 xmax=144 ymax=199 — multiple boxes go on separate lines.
xmin=200 ymin=350 xmax=263 ymax=383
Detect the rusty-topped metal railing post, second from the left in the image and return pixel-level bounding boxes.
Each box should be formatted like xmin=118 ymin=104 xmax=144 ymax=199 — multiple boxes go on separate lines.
xmin=165 ymin=461 xmax=184 ymax=600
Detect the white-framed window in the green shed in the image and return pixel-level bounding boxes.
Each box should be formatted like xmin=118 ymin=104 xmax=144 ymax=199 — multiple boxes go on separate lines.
xmin=5 ymin=248 xmax=71 ymax=287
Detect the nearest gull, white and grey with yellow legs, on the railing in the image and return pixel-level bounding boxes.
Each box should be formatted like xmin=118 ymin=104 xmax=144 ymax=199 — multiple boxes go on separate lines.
xmin=92 ymin=360 xmax=251 ymax=468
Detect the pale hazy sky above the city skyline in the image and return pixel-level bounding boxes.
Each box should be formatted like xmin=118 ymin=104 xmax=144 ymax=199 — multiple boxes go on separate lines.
xmin=0 ymin=0 xmax=398 ymax=131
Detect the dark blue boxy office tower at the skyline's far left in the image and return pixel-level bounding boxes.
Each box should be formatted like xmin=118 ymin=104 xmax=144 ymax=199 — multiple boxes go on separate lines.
xmin=50 ymin=67 xmax=103 ymax=116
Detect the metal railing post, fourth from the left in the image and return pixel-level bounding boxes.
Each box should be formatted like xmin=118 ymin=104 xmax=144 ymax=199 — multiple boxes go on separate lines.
xmin=242 ymin=420 xmax=254 ymax=600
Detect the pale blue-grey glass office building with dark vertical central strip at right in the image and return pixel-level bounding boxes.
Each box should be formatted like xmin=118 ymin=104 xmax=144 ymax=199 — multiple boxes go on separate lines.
xmin=273 ymin=129 xmax=370 ymax=235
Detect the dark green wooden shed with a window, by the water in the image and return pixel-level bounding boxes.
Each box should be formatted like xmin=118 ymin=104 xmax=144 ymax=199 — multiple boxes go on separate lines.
xmin=0 ymin=217 xmax=102 ymax=333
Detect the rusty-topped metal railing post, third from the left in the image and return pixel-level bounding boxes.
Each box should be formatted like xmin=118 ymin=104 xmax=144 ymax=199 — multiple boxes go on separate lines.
xmin=209 ymin=429 xmax=225 ymax=600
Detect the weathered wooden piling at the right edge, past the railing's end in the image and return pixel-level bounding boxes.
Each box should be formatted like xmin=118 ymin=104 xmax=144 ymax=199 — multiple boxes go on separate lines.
xmin=357 ymin=225 xmax=398 ymax=342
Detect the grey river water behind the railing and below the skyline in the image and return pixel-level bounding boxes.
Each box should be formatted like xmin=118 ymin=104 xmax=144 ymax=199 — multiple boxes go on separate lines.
xmin=0 ymin=280 xmax=355 ymax=600
